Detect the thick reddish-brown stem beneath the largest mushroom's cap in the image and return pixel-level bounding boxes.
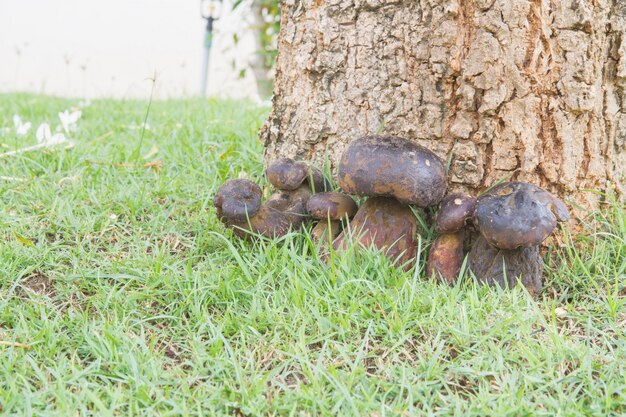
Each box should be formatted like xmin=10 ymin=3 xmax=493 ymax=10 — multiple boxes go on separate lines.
xmin=333 ymin=197 xmax=418 ymax=269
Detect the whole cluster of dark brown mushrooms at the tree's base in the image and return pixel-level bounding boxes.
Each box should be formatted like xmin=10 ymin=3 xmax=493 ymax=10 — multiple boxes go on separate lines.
xmin=214 ymin=135 xmax=569 ymax=294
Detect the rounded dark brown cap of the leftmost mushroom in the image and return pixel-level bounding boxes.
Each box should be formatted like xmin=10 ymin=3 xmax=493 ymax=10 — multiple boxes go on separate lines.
xmin=213 ymin=179 xmax=263 ymax=222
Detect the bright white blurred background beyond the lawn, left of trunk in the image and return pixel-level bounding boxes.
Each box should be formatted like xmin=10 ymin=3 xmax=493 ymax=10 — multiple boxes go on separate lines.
xmin=0 ymin=0 xmax=279 ymax=101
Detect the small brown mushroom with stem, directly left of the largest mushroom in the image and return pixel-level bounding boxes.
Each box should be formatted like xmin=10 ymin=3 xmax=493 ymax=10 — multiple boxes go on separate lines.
xmin=306 ymin=192 xmax=358 ymax=241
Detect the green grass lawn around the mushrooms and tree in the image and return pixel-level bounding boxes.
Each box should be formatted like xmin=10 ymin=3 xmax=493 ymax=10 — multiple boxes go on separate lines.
xmin=0 ymin=95 xmax=626 ymax=416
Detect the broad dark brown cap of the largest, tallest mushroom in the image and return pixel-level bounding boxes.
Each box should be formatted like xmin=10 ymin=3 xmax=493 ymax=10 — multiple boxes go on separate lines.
xmin=338 ymin=135 xmax=446 ymax=207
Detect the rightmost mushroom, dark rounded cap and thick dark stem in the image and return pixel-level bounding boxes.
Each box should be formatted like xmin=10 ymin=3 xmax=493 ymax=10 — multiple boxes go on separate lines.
xmin=469 ymin=182 xmax=569 ymax=295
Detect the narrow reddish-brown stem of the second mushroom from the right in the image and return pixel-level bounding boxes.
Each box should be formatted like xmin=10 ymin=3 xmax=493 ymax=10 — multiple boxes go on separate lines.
xmin=426 ymin=229 xmax=465 ymax=284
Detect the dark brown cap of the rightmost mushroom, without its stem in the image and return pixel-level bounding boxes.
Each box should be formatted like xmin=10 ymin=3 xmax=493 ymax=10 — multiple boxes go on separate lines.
xmin=474 ymin=182 xmax=569 ymax=249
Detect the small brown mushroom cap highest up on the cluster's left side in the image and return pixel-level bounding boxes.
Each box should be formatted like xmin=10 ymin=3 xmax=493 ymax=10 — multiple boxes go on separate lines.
xmin=266 ymin=158 xmax=327 ymax=192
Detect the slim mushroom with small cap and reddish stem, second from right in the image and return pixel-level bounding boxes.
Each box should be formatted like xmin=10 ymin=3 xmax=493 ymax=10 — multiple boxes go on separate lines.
xmin=426 ymin=193 xmax=476 ymax=284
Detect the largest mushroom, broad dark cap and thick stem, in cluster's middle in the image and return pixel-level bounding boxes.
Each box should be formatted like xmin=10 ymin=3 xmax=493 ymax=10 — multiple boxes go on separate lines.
xmin=333 ymin=135 xmax=446 ymax=268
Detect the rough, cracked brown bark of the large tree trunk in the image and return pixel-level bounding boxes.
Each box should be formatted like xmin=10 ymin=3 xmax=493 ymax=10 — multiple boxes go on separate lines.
xmin=261 ymin=0 xmax=626 ymax=208
